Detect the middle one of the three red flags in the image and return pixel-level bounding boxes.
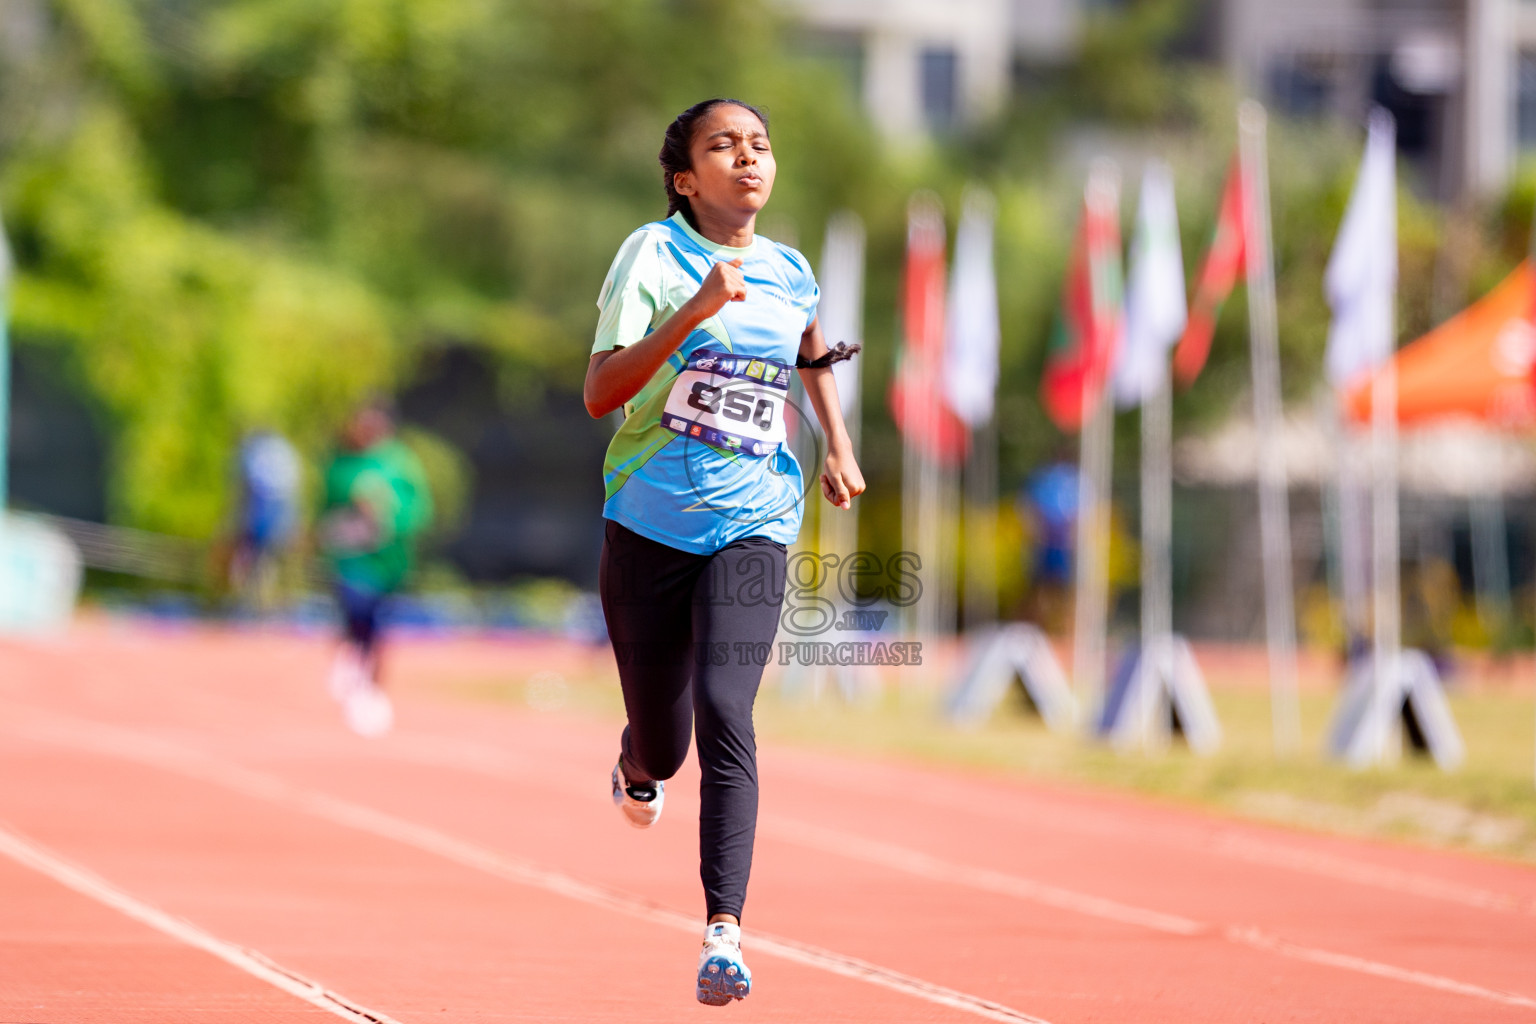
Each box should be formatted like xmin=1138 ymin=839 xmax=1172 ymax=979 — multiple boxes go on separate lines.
xmin=1040 ymin=173 xmax=1121 ymax=430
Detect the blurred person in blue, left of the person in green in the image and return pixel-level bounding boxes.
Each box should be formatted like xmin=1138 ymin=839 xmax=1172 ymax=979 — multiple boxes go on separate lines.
xmin=229 ymin=430 xmax=300 ymax=611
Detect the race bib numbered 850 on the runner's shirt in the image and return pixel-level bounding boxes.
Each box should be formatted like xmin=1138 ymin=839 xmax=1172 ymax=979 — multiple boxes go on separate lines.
xmin=662 ymin=348 xmax=790 ymax=456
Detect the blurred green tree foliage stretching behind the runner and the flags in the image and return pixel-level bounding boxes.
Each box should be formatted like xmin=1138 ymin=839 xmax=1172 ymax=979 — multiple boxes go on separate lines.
xmin=0 ymin=0 xmax=1511 ymax=549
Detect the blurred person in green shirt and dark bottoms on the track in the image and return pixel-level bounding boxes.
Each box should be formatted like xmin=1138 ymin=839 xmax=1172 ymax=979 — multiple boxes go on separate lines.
xmin=318 ymin=401 xmax=432 ymax=735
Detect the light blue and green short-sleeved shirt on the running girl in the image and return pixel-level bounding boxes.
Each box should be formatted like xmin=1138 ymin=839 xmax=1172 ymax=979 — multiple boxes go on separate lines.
xmin=591 ymin=213 xmax=820 ymax=554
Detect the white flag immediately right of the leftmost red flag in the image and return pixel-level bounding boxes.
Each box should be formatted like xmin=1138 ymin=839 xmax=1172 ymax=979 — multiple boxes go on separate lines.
xmin=943 ymin=189 xmax=1000 ymax=430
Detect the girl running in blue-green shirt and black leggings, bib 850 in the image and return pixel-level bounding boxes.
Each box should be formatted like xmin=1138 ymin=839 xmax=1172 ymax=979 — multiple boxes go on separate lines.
xmin=585 ymin=100 xmax=865 ymax=1006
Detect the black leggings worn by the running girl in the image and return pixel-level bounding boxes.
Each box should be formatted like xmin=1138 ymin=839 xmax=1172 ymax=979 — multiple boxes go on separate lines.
xmin=599 ymin=520 xmax=785 ymax=918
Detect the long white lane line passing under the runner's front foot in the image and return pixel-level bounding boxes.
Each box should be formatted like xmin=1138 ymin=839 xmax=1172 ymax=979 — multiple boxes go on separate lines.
xmin=6 ymin=714 xmax=1049 ymax=1024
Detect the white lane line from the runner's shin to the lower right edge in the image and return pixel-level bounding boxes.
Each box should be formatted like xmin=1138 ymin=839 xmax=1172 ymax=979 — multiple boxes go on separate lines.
xmin=765 ymin=817 xmax=1536 ymax=1009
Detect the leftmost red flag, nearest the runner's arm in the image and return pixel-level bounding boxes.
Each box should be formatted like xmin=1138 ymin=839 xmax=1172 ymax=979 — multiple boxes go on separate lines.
xmin=889 ymin=191 xmax=969 ymax=462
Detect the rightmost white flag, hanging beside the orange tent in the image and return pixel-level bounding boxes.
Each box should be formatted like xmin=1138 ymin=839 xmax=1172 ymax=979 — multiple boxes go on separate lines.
xmin=1322 ymin=107 xmax=1398 ymax=388
